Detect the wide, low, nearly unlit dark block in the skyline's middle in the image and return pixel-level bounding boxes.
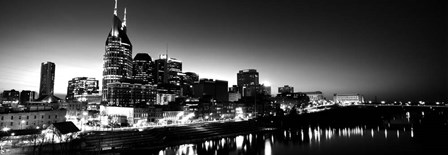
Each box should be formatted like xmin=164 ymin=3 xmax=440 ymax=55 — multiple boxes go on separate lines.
xmin=193 ymin=79 xmax=229 ymax=102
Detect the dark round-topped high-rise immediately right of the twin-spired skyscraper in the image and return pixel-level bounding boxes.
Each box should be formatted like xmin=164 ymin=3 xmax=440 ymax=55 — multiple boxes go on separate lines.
xmin=132 ymin=53 xmax=154 ymax=84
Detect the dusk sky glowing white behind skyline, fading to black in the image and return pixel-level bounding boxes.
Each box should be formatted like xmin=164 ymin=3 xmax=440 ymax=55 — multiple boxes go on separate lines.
xmin=0 ymin=0 xmax=448 ymax=101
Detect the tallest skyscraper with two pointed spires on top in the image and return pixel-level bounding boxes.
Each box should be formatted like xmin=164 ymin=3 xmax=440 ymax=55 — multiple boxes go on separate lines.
xmin=102 ymin=1 xmax=132 ymax=101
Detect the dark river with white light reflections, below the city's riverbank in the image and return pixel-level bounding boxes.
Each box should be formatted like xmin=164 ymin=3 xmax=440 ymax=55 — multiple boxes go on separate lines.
xmin=148 ymin=108 xmax=448 ymax=155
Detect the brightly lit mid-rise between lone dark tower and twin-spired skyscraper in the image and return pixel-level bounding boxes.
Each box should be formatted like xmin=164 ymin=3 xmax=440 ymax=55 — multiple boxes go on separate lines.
xmin=65 ymin=77 xmax=99 ymax=102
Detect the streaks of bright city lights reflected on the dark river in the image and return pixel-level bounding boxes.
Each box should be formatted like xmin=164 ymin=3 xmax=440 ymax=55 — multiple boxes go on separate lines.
xmin=159 ymin=126 xmax=414 ymax=155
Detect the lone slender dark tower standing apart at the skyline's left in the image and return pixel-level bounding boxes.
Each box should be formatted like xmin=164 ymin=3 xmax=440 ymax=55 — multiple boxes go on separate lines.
xmin=39 ymin=61 xmax=56 ymax=98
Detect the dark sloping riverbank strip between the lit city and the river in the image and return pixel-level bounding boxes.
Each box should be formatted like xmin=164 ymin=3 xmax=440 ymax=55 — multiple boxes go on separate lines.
xmin=5 ymin=106 xmax=448 ymax=154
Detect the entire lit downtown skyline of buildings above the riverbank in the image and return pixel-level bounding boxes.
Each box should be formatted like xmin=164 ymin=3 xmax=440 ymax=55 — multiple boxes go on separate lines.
xmin=1 ymin=0 xmax=368 ymax=132
